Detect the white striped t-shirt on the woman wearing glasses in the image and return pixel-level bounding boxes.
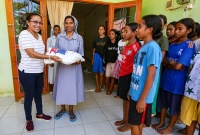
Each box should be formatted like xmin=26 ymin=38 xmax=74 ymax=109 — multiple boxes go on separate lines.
xmin=18 ymin=30 xmax=45 ymax=73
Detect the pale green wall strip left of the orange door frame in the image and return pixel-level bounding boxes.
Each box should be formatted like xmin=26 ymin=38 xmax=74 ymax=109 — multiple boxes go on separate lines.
xmin=0 ymin=0 xmax=14 ymax=97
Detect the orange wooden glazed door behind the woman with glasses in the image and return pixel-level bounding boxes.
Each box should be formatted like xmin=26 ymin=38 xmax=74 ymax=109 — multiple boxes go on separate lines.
xmin=5 ymin=0 xmax=49 ymax=101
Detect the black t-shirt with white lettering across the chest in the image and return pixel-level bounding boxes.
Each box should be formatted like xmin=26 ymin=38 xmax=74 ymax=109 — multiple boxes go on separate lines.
xmin=104 ymin=41 xmax=118 ymax=66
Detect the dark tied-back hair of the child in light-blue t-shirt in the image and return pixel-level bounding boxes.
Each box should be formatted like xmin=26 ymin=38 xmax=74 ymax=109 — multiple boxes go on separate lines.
xmin=142 ymin=15 xmax=163 ymax=39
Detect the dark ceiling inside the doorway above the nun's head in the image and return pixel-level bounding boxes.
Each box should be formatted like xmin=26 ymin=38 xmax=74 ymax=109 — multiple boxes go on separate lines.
xmin=72 ymin=2 xmax=98 ymax=18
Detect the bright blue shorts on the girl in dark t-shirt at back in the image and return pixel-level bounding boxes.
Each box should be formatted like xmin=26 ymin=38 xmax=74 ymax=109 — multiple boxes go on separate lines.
xmin=92 ymin=53 xmax=105 ymax=73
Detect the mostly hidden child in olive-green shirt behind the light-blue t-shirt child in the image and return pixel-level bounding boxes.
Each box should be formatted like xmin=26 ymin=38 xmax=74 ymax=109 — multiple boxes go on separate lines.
xmin=152 ymin=15 xmax=169 ymax=116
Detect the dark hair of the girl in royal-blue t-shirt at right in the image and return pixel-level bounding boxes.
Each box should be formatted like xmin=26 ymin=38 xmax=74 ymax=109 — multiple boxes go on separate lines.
xmin=178 ymin=18 xmax=196 ymax=38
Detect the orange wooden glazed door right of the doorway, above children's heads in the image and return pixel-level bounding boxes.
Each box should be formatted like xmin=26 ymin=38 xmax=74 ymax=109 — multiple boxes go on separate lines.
xmin=108 ymin=0 xmax=142 ymax=31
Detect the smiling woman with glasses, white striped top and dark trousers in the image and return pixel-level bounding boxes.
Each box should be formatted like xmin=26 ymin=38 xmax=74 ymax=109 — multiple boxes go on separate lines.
xmin=18 ymin=13 xmax=61 ymax=132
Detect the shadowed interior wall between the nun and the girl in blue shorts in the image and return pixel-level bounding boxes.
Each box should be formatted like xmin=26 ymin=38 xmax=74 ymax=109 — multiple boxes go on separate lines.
xmin=84 ymin=5 xmax=108 ymax=60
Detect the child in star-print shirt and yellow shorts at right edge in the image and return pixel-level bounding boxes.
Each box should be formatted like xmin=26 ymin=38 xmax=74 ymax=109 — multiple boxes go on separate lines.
xmin=180 ymin=51 xmax=200 ymax=135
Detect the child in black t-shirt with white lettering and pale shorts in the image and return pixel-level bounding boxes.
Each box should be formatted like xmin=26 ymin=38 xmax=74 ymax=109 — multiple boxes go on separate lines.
xmin=104 ymin=29 xmax=118 ymax=95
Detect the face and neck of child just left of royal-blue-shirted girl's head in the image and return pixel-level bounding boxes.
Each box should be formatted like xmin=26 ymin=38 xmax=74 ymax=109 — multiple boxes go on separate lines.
xmin=166 ymin=21 xmax=177 ymax=45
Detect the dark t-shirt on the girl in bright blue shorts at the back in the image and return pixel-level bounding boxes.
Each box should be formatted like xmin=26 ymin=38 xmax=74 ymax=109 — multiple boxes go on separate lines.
xmin=92 ymin=37 xmax=109 ymax=58
